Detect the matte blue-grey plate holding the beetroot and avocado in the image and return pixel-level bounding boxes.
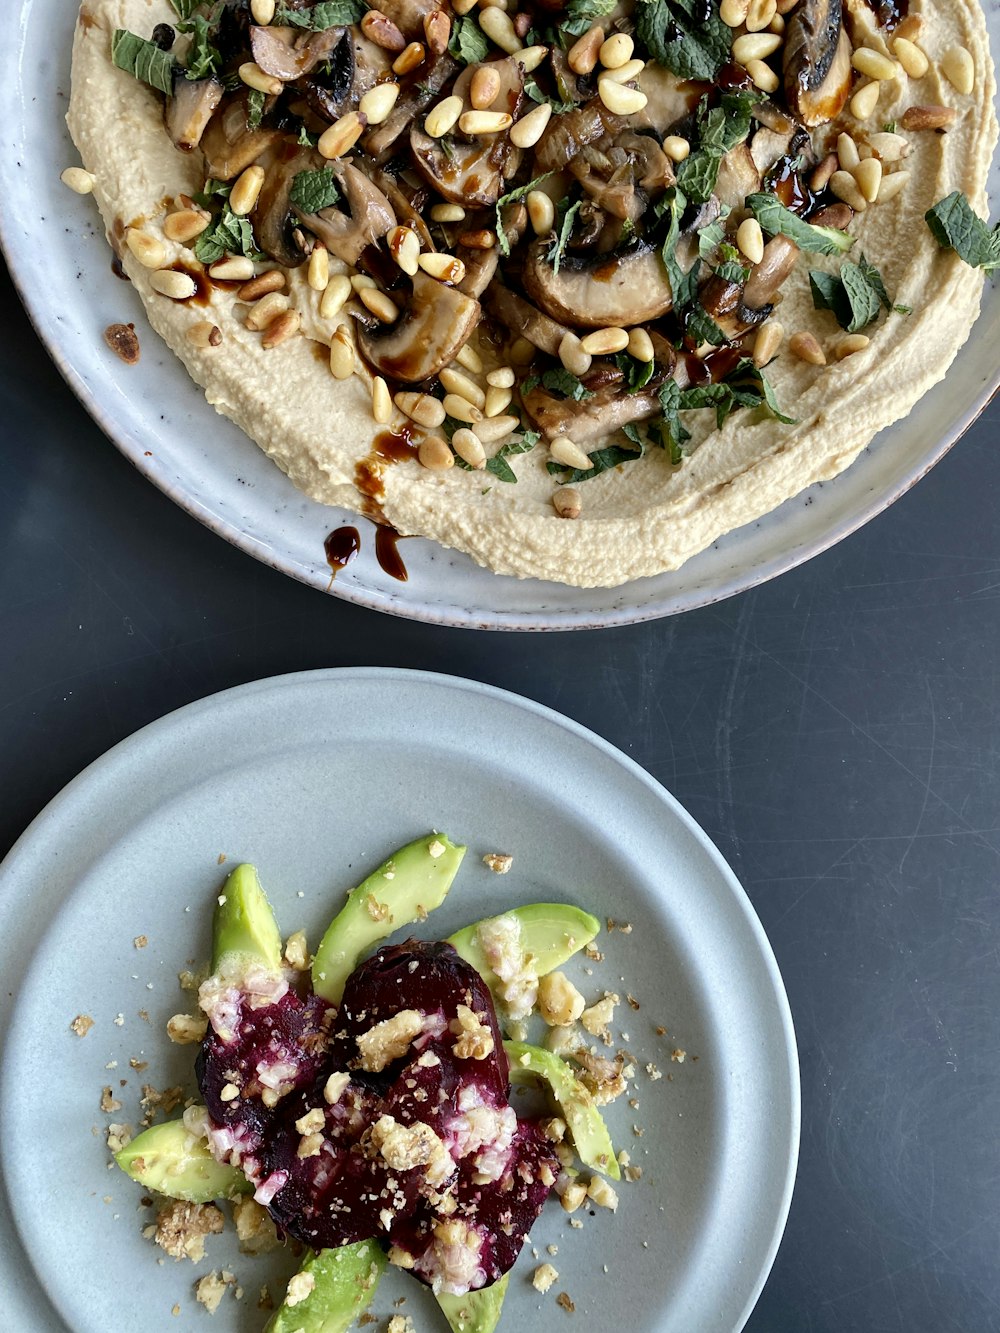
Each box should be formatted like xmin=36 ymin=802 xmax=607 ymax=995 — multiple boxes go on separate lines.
xmin=0 ymin=670 xmax=799 ymax=1333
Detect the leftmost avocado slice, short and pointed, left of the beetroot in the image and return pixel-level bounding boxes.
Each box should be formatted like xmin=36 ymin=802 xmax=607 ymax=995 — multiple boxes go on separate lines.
xmin=115 ymin=1120 xmax=252 ymax=1204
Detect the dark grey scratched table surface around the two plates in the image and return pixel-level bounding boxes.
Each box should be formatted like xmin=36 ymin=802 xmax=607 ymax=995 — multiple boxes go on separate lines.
xmin=0 ymin=251 xmax=1000 ymax=1333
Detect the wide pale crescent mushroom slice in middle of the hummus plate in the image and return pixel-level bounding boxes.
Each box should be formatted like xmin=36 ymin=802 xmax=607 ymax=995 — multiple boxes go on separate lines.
xmin=521 ymin=240 xmax=673 ymax=328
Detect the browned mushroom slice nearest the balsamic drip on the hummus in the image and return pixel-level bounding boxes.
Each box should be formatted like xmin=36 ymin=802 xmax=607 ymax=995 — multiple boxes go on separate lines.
xmin=357 ymin=271 xmax=481 ymax=384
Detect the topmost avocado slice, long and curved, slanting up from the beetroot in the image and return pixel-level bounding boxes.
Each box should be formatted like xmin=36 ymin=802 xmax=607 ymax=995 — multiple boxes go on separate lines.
xmin=312 ymin=833 xmax=465 ymax=1004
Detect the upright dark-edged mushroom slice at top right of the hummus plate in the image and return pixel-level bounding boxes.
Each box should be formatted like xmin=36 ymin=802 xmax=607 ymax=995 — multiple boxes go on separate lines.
xmin=784 ymin=0 xmax=853 ymax=127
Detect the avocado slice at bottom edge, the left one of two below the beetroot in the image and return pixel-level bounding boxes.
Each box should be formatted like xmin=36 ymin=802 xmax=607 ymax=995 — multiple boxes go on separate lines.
xmin=264 ymin=1241 xmax=387 ymax=1333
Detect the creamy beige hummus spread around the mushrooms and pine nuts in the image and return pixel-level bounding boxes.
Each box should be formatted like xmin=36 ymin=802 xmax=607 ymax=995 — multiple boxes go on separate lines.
xmin=68 ymin=0 xmax=997 ymax=587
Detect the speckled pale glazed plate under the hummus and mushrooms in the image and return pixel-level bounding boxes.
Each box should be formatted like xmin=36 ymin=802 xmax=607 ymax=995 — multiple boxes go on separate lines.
xmin=0 ymin=0 xmax=1000 ymax=629
